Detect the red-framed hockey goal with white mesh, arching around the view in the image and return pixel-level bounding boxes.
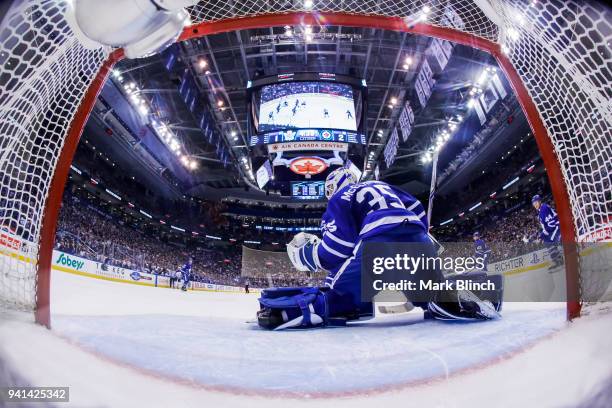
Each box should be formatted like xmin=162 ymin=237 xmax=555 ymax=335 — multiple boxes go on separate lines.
xmin=0 ymin=0 xmax=612 ymax=323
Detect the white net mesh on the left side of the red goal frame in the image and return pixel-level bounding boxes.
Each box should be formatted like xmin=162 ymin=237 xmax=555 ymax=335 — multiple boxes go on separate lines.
xmin=0 ymin=1 xmax=106 ymax=310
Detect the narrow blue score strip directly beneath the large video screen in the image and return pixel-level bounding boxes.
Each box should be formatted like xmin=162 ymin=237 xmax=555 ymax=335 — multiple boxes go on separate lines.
xmin=249 ymin=129 xmax=366 ymax=146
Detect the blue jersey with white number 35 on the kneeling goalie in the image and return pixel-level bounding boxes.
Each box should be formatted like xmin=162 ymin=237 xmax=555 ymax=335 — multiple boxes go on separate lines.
xmin=317 ymin=181 xmax=428 ymax=271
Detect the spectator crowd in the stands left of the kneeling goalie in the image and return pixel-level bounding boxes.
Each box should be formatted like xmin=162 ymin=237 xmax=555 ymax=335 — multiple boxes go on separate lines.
xmin=55 ymin=194 xmax=319 ymax=287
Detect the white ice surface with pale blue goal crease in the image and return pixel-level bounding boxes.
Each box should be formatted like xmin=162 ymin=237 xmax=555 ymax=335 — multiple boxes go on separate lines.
xmin=0 ymin=273 xmax=612 ymax=407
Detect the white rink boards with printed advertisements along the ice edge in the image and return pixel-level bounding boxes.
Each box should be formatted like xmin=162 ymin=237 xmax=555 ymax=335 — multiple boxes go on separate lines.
xmin=0 ymin=231 xmax=612 ymax=302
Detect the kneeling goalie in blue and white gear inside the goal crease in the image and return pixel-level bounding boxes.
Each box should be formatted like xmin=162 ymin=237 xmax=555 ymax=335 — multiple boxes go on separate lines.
xmin=257 ymin=168 xmax=502 ymax=330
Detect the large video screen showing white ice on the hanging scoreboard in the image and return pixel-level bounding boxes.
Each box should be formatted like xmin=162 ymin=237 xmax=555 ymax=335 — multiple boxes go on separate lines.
xmin=258 ymin=82 xmax=357 ymax=133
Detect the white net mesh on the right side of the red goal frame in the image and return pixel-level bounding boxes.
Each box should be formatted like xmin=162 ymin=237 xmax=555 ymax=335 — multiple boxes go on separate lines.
xmin=497 ymin=1 xmax=612 ymax=240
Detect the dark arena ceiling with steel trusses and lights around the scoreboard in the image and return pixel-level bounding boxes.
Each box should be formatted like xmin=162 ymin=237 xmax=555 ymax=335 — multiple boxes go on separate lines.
xmin=89 ymin=26 xmax=520 ymax=202
